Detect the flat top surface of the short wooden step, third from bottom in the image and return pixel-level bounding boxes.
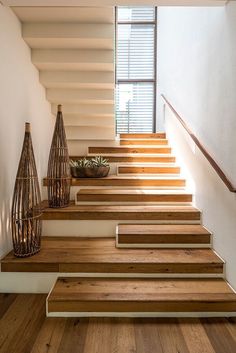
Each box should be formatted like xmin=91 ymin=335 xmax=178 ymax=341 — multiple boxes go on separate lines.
xmin=118 ymin=224 xmax=211 ymax=236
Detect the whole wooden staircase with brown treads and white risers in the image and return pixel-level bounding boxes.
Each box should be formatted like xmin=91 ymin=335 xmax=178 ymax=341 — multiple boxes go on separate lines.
xmin=1 ymin=133 xmax=236 ymax=316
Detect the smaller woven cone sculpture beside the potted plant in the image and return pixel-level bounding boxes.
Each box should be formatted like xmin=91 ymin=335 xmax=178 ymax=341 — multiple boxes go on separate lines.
xmin=47 ymin=105 xmax=71 ymax=208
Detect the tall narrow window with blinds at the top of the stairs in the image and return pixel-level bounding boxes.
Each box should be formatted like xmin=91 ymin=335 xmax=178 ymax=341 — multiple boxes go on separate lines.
xmin=116 ymin=7 xmax=157 ymax=133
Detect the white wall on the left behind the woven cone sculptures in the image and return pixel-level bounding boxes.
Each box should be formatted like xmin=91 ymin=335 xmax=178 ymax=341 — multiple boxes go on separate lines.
xmin=0 ymin=5 xmax=54 ymax=258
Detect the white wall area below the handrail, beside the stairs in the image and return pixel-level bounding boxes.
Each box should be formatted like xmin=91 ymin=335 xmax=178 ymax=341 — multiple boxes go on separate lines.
xmin=165 ymin=103 xmax=236 ymax=288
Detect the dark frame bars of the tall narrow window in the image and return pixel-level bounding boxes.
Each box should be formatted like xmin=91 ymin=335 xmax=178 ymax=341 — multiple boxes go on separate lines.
xmin=115 ymin=6 xmax=157 ymax=133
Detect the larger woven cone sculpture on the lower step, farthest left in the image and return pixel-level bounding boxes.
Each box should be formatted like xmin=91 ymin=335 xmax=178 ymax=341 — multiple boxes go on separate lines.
xmin=12 ymin=123 xmax=42 ymax=257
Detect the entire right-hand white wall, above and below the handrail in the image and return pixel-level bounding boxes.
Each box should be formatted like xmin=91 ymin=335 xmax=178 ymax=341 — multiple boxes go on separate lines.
xmin=158 ymin=2 xmax=236 ymax=289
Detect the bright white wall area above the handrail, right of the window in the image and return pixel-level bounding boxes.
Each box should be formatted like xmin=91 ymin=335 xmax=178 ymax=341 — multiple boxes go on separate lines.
xmin=158 ymin=1 xmax=236 ymax=185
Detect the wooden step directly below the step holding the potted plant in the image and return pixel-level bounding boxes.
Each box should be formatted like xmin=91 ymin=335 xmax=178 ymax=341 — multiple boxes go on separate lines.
xmin=76 ymin=188 xmax=192 ymax=203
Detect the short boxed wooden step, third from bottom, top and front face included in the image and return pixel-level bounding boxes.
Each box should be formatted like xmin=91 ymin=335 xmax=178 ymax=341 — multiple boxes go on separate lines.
xmin=116 ymin=224 xmax=212 ymax=248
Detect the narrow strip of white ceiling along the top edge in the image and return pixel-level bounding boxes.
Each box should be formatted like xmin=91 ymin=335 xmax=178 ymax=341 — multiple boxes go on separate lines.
xmin=0 ymin=0 xmax=228 ymax=6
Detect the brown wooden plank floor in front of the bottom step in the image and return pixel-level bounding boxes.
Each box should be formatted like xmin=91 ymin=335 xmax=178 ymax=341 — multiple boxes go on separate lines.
xmin=0 ymin=294 xmax=236 ymax=353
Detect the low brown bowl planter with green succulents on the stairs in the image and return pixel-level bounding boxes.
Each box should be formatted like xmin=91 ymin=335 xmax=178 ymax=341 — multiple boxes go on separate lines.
xmin=70 ymin=156 xmax=110 ymax=178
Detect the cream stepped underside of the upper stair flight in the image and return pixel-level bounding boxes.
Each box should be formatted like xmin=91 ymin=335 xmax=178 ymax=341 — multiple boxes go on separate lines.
xmin=12 ymin=6 xmax=115 ymax=146
